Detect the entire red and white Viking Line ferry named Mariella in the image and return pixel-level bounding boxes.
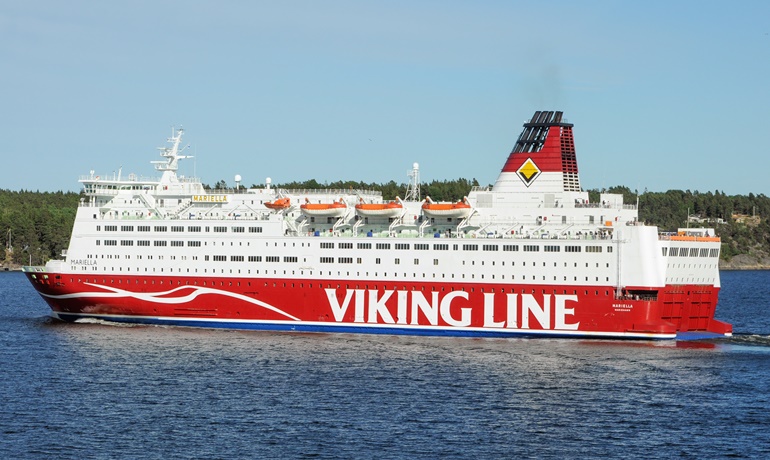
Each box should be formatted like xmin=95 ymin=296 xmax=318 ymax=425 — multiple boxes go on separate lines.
xmin=23 ymin=111 xmax=732 ymax=339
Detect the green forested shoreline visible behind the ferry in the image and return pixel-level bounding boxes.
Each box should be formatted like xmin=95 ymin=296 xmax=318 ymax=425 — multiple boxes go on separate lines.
xmin=0 ymin=182 xmax=770 ymax=269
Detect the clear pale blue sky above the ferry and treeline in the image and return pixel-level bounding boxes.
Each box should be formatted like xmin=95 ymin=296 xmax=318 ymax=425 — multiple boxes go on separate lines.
xmin=0 ymin=0 xmax=770 ymax=195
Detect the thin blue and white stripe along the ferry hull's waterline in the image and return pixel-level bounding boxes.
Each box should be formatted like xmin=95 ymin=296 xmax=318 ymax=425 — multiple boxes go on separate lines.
xmin=56 ymin=313 xmax=673 ymax=340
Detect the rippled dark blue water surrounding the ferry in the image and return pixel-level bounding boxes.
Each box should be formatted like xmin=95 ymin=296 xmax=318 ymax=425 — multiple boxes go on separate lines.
xmin=0 ymin=272 xmax=770 ymax=459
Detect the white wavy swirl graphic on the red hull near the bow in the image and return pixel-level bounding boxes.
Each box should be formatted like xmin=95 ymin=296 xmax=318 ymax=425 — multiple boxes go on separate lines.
xmin=40 ymin=283 xmax=299 ymax=321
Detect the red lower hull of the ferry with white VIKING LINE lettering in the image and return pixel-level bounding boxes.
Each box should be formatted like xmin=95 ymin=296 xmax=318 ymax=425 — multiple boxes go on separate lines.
xmin=26 ymin=272 xmax=732 ymax=339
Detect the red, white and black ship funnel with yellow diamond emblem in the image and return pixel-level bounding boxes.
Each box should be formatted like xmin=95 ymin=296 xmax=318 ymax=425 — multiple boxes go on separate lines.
xmin=493 ymin=111 xmax=581 ymax=193
